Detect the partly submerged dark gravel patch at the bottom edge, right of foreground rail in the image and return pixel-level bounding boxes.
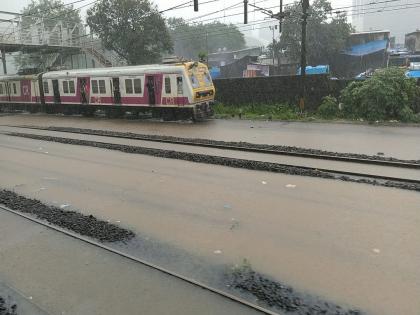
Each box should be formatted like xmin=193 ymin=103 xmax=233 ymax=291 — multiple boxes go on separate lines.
xmin=229 ymin=265 xmax=364 ymax=315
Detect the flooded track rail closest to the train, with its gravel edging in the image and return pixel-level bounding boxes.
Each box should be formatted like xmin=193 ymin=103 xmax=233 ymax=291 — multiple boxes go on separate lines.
xmin=1 ymin=125 xmax=420 ymax=169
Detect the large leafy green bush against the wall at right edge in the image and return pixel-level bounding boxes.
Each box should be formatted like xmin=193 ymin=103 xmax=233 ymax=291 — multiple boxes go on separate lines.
xmin=341 ymin=68 xmax=420 ymax=122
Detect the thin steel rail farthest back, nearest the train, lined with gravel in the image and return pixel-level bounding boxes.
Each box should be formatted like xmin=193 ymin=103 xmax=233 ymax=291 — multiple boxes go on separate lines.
xmin=4 ymin=125 xmax=420 ymax=169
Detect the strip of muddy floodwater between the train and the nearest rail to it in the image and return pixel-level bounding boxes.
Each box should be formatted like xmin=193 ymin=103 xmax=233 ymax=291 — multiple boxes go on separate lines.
xmin=0 ymin=114 xmax=420 ymax=159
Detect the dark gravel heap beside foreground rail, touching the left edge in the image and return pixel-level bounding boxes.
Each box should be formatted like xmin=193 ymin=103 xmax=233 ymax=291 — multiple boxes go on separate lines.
xmin=0 ymin=190 xmax=135 ymax=243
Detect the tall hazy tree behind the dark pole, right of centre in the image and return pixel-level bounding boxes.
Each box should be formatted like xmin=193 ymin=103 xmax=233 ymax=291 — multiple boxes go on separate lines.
xmin=280 ymin=0 xmax=353 ymax=65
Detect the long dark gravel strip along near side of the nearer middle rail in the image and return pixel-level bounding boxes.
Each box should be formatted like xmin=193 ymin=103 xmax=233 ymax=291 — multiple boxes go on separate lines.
xmin=7 ymin=132 xmax=420 ymax=191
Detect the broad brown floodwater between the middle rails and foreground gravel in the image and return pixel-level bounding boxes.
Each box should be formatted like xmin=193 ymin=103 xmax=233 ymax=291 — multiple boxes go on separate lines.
xmin=0 ymin=136 xmax=420 ymax=315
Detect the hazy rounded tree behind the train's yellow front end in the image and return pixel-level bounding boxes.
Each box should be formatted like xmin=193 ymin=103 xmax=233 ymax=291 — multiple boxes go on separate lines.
xmin=168 ymin=18 xmax=245 ymax=59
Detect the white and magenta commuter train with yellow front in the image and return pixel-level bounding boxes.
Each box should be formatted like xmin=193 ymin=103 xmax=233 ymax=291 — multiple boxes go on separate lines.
xmin=0 ymin=62 xmax=215 ymax=121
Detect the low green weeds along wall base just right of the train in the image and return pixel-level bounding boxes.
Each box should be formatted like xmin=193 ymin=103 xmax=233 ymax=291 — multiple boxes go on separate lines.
xmin=213 ymin=103 xmax=300 ymax=120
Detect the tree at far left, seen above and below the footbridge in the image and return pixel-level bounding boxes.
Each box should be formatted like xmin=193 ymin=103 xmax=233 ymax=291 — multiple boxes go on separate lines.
xmin=15 ymin=0 xmax=81 ymax=70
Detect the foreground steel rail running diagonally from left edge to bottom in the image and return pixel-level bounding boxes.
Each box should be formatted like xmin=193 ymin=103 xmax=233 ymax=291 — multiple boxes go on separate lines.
xmin=0 ymin=205 xmax=280 ymax=315
